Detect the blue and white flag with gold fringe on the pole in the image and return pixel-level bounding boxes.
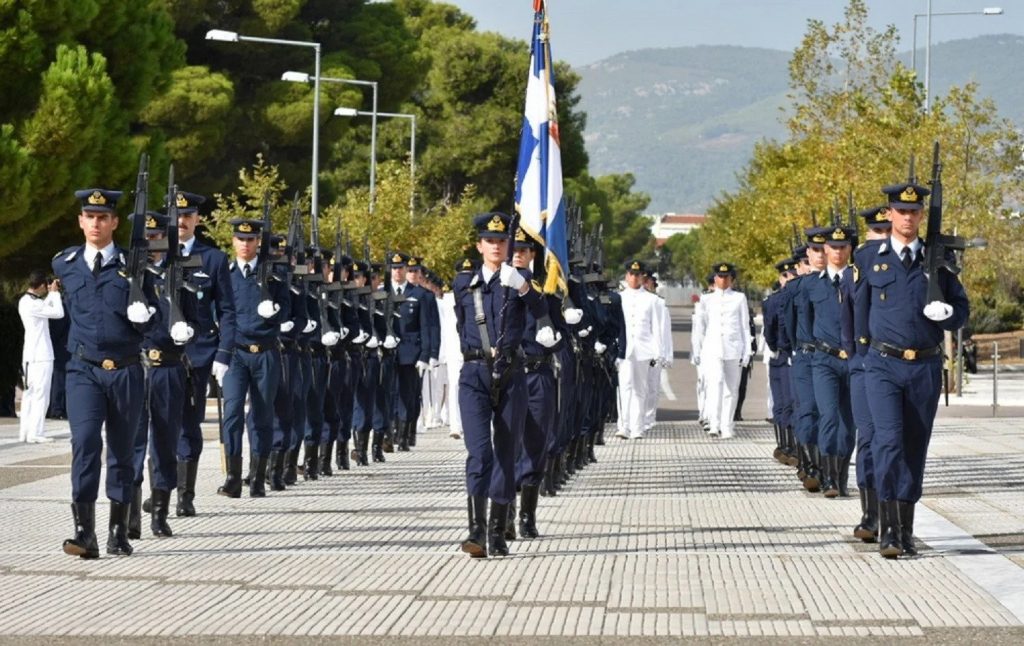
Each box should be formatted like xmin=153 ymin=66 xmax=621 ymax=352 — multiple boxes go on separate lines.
xmin=515 ymin=0 xmax=568 ymax=294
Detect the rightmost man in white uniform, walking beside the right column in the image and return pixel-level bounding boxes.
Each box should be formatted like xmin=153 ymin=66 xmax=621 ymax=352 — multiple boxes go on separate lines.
xmin=692 ymin=262 xmax=753 ymax=439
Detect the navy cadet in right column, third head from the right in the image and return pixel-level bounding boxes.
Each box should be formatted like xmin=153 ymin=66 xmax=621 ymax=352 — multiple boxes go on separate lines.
xmin=797 ymin=225 xmax=856 ymax=498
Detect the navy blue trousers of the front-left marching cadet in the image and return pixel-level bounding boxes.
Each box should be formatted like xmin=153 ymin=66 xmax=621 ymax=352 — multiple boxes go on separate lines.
xmin=67 ymin=357 xmax=144 ymax=504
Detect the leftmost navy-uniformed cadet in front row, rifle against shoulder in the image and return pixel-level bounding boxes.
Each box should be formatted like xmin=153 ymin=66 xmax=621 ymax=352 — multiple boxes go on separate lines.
xmin=52 ymin=188 xmax=159 ymax=559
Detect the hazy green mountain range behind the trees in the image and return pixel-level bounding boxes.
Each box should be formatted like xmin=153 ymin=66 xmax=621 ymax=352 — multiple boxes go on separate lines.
xmin=577 ymin=35 xmax=1024 ymax=213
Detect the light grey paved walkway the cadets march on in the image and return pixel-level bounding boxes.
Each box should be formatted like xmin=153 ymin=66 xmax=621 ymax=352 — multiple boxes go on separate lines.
xmin=0 ymin=307 xmax=1024 ymax=644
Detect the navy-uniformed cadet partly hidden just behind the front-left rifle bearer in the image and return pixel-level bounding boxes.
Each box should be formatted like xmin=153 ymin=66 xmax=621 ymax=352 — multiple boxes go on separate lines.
xmin=128 ymin=211 xmax=196 ymax=539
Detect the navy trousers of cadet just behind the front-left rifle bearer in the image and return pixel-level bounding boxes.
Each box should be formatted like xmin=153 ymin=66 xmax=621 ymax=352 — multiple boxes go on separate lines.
xmin=133 ymin=365 xmax=186 ymax=490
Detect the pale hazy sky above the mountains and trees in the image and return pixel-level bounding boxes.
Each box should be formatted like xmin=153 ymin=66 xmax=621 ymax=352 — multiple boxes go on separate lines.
xmin=445 ymin=0 xmax=1024 ymax=66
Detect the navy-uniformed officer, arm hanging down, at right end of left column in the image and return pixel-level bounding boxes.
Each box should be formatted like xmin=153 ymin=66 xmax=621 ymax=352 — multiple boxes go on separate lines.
xmin=388 ymin=253 xmax=428 ymax=450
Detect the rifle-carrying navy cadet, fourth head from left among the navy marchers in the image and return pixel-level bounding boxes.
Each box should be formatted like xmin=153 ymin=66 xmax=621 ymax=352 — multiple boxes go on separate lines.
xmin=217 ymin=220 xmax=289 ymax=498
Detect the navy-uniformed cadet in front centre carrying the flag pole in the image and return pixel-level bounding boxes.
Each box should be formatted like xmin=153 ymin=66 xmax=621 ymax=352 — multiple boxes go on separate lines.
xmin=455 ymin=213 xmax=554 ymax=557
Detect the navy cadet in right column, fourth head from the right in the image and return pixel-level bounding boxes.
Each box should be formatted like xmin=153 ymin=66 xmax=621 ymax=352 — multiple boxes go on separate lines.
xmin=785 ymin=226 xmax=825 ymax=491
